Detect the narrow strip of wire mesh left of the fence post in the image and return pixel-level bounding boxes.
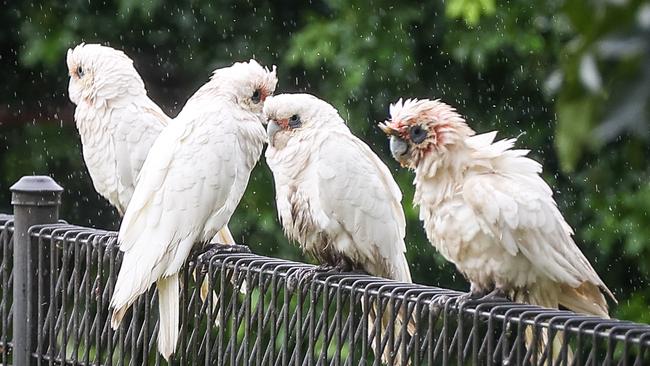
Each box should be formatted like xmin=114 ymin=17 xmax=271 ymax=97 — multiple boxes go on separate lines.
xmin=0 ymin=214 xmax=13 ymax=365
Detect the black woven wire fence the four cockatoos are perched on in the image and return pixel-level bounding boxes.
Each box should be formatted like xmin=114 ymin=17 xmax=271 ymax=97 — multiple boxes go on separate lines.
xmin=0 ymin=176 xmax=650 ymax=365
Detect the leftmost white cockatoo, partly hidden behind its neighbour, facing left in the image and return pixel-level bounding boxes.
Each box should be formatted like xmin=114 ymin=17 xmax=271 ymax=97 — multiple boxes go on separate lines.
xmin=66 ymin=43 xmax=235 ymax=244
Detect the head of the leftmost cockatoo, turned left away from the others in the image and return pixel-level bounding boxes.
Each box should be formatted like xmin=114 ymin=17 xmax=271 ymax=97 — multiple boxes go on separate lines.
xmin=66 ymin=43 xmax=147 ymax=105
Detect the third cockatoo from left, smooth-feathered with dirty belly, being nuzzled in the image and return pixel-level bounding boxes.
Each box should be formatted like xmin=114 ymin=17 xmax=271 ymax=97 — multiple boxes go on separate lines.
xmin=264 ymin=94 xmax=411 ymax=362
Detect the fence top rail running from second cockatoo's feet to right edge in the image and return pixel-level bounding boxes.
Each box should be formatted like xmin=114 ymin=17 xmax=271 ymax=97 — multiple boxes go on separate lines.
xmin=199 ymin=249 xmax=650 ymax=347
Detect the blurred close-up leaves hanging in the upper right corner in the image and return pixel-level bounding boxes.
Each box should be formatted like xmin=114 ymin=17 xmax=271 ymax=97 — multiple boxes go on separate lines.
xmin=556 ymin=0 xmax=650 ymax=172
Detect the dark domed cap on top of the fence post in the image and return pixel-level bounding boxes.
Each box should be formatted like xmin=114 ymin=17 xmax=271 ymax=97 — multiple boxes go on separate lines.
xmin=9 ymin=175 xmax=63 ymax=206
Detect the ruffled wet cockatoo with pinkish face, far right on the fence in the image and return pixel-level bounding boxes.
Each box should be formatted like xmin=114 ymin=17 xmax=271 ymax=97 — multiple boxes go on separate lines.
xmin=381 ymin=99 xmax=614 ymax=317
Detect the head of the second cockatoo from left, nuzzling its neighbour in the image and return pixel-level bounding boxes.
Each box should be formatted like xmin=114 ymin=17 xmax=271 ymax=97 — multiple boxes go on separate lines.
xmin=212 ymin=59 xmax=278 ymax=116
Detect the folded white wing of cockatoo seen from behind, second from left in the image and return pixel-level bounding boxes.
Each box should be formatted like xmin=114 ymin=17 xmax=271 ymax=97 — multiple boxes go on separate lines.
xmin=113 ymin=109 xmax=242 ymax=307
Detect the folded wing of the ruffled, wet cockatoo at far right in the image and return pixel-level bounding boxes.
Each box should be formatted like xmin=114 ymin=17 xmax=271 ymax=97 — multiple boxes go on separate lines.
xmin=462 ymin=164 xmax=611 ymax=295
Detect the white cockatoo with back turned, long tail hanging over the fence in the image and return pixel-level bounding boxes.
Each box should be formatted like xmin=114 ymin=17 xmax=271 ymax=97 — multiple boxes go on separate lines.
xmin=110 ymin=60 xmax=277 ymax=359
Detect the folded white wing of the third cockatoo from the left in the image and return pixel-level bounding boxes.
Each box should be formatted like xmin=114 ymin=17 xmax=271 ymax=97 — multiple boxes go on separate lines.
xmin=316 ymin=131 xmax=404 ymax=282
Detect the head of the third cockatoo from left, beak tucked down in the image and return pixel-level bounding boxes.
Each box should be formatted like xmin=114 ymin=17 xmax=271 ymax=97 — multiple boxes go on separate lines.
xmin=264 ymin=94 xmax=346 ymax=147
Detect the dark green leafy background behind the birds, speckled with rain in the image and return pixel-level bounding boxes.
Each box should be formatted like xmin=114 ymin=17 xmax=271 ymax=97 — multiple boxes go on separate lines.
xmin=0 ymin=0 xmax=650 ymax=322
